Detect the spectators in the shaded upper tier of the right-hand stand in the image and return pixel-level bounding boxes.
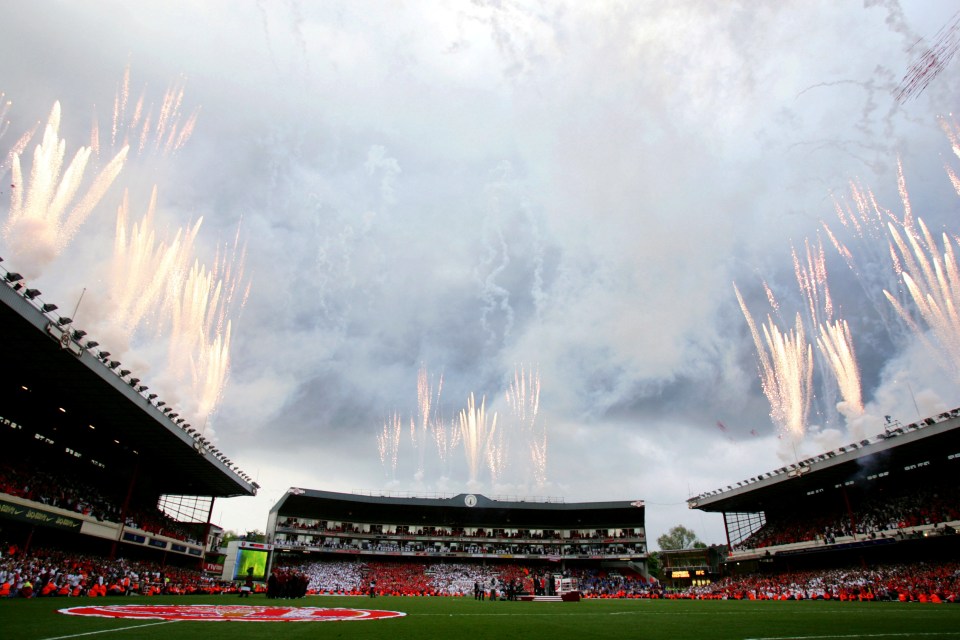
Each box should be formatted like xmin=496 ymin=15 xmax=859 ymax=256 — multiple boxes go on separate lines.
xmin=736 ymin=488 xmax=960 ymax=549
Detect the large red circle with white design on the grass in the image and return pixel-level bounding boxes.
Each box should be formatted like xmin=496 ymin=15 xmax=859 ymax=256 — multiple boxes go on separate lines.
xmin=59 ymin=604 xmax=407 ymax=622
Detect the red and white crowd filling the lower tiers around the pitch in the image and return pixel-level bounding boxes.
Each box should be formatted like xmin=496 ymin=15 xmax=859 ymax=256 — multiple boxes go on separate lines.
xmin=7 ymin=545 xmax=960 ymax=603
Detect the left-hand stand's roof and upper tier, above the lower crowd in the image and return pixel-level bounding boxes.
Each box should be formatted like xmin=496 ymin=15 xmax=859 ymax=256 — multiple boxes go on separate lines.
xmin=0 ymin=268 xmax=258 ymax=565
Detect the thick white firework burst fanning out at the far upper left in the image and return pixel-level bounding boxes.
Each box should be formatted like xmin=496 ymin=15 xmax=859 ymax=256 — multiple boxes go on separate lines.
xmin=3 ymin=102 xmax=127 ymax=277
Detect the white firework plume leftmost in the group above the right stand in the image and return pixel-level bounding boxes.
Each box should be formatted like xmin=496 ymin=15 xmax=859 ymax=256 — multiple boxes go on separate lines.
xmin=734 ymin=285 xmax=813 ymax=442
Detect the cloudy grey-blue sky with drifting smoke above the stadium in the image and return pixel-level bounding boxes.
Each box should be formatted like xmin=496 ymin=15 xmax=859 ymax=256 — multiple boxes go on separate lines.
xmin=0 ymin=0 xmax=960 ymax=543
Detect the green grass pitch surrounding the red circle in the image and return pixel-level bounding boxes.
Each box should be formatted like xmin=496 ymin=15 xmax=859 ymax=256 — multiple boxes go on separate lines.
xmin=0 ymin=596 xmax=960 ymax=640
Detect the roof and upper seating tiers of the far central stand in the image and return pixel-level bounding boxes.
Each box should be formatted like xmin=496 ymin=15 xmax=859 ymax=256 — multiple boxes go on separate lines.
xmin=267 ymin=487 xmax=647 ymax=575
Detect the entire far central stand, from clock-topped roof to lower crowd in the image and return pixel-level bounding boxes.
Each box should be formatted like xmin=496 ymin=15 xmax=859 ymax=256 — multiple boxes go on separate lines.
xmin=267 ymin=488 xmax=647 ymax=597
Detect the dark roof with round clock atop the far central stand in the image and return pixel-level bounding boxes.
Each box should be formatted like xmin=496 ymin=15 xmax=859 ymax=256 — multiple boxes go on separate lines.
xmin=271 ymin=488 xmax=645 ymax=529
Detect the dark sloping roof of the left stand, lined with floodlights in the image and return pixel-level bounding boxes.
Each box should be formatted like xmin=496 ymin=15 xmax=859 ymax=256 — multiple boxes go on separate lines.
xmin=0 ymin=274 xmax=257 ymax=497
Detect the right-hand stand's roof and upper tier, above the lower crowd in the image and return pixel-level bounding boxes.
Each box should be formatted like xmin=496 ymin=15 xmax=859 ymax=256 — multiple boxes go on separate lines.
xmin=687 ymin=408 xmax=960 ymax=571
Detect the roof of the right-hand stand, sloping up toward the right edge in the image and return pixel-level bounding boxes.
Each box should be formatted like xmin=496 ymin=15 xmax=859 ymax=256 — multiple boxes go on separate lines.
xmin=687 ymin=408 xmax=960 ymax=513
